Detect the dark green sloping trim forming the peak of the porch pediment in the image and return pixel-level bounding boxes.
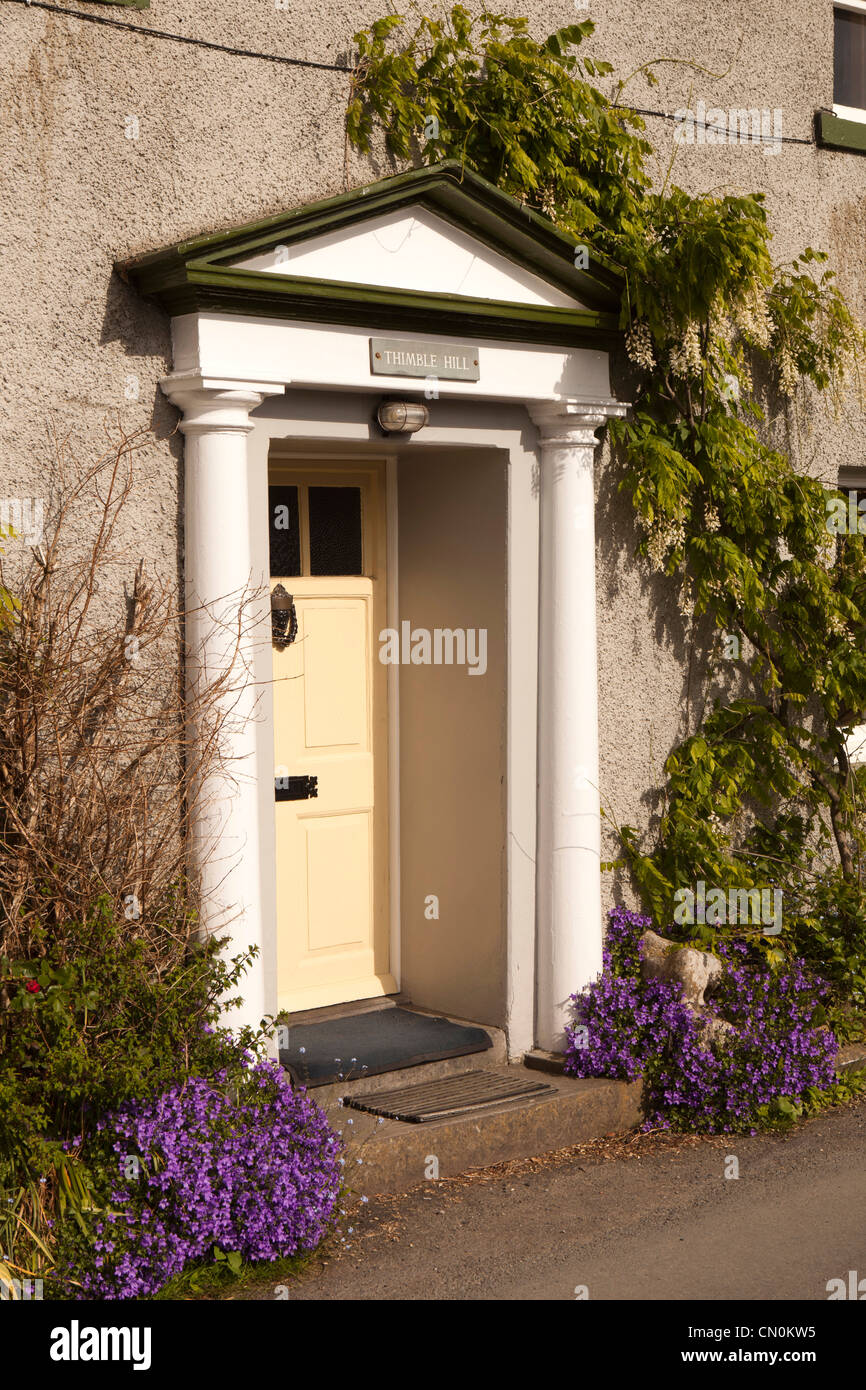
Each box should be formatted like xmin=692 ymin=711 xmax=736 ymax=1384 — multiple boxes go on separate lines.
xmin=117 ymin=161 xmax=624 ymax=331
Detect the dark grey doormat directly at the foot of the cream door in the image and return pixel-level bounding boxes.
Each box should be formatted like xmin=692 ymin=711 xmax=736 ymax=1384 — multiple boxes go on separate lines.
xmin=279 ymin=1008 xmax=493 ymax=1086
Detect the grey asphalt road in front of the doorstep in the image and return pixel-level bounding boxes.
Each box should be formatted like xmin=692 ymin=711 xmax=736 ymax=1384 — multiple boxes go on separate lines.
xmin=262 ymin=1104 xmax=866 ymax=1301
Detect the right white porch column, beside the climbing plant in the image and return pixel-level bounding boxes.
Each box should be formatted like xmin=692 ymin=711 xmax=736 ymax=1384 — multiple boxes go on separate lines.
xmin=530 ymin=400 xmax=627 ymax=1051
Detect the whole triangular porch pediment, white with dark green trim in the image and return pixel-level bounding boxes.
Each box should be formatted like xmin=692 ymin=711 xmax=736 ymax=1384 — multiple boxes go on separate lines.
xmin=118 ymin=163 xmax=621 ymax=346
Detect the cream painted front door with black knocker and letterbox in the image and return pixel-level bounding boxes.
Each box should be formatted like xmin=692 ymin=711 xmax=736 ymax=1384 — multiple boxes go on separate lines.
xmin=268 ymin=460 xmax=396 ymax=1012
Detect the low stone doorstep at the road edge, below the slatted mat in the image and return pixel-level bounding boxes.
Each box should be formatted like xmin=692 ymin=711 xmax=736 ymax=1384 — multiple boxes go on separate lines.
xmin=332 ymin=1054 xmax=642 ymax=1197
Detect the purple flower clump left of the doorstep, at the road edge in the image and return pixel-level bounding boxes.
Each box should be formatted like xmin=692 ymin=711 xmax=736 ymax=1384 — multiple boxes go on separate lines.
xmin=82 ymin=1062 xmax=342 ymax=1298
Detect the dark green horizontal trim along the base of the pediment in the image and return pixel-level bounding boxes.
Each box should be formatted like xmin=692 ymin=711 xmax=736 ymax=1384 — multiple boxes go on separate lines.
xmin=147 ymin=259 xmax=619 ymax=348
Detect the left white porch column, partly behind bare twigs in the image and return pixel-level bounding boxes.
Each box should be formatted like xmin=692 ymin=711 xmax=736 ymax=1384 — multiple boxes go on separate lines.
xmin=161 ymin=374 xmax=282 ymax=1029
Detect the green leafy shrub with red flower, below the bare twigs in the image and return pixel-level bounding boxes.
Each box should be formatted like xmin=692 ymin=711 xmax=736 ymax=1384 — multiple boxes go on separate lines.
xmin=0 ymin=902 xmax=257 ymax=1166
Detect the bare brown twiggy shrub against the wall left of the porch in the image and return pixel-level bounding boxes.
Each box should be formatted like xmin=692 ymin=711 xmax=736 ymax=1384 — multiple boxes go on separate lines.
xmin=0 ymin=432 xmax=262 ymax=972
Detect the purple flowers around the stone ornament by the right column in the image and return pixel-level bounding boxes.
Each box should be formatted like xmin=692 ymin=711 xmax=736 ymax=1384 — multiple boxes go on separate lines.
xmin=566 ymin=908 xmax=837 ymax=1133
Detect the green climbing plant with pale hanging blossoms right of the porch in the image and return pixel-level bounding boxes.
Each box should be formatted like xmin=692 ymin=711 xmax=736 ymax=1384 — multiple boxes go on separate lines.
xmin=346 ymin=4 xmax=866 ymax=1004
